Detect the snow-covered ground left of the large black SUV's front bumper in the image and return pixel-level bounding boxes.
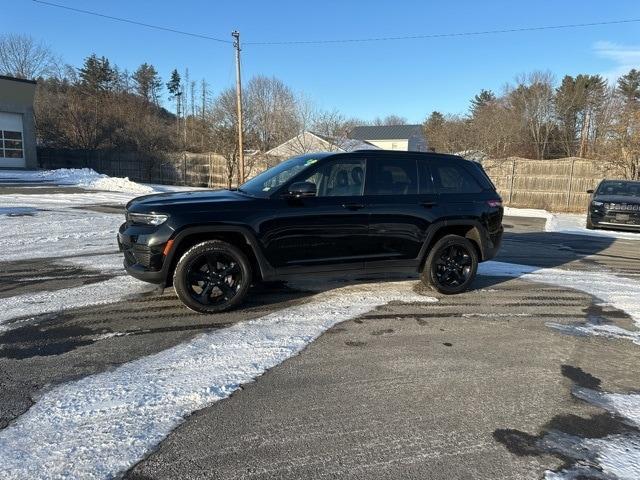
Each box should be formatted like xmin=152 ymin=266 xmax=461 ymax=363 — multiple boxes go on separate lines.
xmin=0 ymin=169 xmax=195 ymax=329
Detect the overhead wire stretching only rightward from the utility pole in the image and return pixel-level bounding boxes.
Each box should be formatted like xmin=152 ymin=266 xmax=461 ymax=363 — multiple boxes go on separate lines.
xmin=244 ymin=18 xmax=640 ymax=45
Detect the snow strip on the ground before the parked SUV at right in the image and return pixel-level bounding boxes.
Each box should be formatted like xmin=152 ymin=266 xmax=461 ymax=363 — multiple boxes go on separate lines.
xmin=504 ymin=207 xmax=640 ymax=240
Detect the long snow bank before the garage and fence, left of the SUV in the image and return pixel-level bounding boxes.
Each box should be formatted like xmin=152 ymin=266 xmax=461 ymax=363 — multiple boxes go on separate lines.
xmin=0 ymin=168 xmax=155 ymax=195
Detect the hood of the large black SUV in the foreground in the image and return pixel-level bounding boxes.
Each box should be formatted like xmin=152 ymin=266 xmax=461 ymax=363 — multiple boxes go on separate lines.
xmin=127 ymin=190 xmax=252 ymax=213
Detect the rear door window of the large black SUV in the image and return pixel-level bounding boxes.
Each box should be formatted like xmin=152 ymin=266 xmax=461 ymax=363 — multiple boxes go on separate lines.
xmin=366 ymin=158 xmax=418 ymax=195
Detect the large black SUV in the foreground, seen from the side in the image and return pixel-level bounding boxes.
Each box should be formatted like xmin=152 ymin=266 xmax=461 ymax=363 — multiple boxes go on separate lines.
xmin=118 ymin=150 xmax=503 ymax=313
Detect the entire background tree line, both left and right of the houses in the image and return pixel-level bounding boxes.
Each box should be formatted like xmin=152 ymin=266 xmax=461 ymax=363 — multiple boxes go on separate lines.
xmin=0 ymin=34 xmax=640 ymax=178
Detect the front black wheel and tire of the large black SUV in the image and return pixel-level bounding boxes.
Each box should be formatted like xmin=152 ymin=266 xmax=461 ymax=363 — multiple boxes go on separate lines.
xmin=173 ymin=240 xmax=251 ymax=313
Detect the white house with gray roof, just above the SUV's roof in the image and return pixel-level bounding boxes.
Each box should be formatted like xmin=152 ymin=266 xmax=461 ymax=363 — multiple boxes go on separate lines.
xmin=349 ymin=125 xmax=427 ymax=152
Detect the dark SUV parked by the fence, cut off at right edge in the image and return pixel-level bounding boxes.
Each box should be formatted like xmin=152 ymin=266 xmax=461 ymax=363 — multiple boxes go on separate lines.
xmin=587 ymin=180 xmax=640 ymax=231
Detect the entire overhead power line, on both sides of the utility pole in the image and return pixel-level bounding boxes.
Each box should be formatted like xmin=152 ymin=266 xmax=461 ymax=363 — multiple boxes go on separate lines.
xmin=33 ymin=0 xmax=640 ymax=46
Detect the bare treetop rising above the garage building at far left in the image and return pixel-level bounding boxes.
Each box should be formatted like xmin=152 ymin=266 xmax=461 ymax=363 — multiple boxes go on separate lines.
xmin=0 ymin=33 xmax=57 ymax=78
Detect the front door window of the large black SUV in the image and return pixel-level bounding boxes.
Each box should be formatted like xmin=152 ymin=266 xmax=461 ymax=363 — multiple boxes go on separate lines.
xmin=302 ymin=159 xmax=365 ymax=197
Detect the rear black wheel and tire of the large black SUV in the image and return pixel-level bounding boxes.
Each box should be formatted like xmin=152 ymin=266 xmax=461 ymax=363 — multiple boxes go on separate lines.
xmin=420 ymin=235 xmax=478 ymax=295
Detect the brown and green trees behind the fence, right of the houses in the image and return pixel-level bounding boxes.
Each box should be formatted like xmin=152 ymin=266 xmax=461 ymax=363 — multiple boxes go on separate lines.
xmin=424 ymin=69 xmax=640 ymax=179
